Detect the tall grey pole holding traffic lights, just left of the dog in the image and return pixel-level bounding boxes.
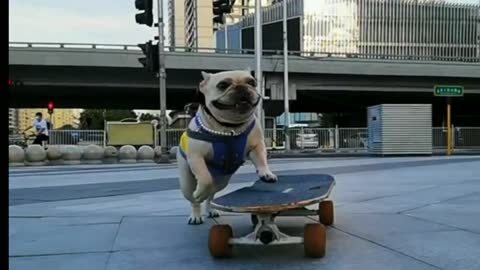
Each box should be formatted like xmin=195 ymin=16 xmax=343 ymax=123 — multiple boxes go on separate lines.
xmin=157 ymin=0 xmax=168 ymax=154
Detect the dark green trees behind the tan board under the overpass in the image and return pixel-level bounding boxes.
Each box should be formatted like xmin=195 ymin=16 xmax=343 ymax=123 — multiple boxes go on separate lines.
xmin=80 ymin=109 xmax=137 ymax=129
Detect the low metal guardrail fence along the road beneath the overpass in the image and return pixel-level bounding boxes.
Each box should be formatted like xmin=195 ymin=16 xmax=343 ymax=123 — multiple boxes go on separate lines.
xmin=13 ymin=127 xmax=480 ymax=150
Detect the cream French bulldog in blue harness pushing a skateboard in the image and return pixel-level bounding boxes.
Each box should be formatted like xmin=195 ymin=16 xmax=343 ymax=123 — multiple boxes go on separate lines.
xmin=177 ymin=71 xmax=277 ymax=224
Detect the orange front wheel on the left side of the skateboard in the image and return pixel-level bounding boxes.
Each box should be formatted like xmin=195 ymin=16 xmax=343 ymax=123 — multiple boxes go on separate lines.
xmin=208 ymin=225 xmax=233 ymax=258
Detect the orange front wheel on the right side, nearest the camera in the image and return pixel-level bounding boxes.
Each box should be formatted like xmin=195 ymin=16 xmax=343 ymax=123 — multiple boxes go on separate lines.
xmin=303 ymin=223 xmax=327 ymax=258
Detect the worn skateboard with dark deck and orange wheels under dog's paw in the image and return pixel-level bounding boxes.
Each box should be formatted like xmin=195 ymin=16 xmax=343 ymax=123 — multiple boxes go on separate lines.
xmin=208 ymin=174 xmax=335 ymax=258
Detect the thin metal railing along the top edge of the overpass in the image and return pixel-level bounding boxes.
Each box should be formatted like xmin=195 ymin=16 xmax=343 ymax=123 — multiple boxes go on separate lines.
xmin=9 ymin=42 xmax=480 ymax=63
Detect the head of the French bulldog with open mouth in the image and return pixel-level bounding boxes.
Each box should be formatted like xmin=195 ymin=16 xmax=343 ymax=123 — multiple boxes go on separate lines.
xmin=200 ymin=70 xmax=261 ymax=124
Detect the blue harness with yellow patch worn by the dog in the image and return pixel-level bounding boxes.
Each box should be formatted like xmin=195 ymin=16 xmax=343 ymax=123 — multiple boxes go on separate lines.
xmin=179 ymin=115 xmax=255 ymax=179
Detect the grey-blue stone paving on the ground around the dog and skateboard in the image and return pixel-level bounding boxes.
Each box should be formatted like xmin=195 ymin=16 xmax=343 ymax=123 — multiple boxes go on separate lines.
xmin=9 ymin=157 xmax=480 ymax=270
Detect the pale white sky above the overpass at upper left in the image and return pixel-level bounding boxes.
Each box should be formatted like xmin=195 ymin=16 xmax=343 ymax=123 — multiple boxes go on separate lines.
xmin=8 ymin=0 xmax=168 ymax=44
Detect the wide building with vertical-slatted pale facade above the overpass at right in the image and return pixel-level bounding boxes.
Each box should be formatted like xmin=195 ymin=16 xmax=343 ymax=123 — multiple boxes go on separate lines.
xmin=217 ymin=0 xmax=480 ymax=62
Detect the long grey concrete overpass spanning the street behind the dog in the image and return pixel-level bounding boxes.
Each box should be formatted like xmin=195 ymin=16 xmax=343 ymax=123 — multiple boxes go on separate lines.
xmin=9 ymin=42 xmax=480 ymax=123
